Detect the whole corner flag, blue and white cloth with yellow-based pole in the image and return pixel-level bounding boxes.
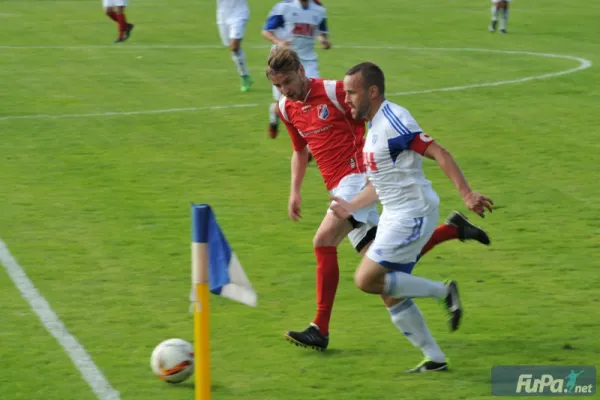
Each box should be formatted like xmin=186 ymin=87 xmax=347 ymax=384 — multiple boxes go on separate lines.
xmin=190 ymin=204 xmax=257 ymax=400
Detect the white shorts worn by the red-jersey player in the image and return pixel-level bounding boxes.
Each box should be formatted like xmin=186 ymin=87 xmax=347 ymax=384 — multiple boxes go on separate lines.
xmin=327 ymin=174 xmax=379 ymax=250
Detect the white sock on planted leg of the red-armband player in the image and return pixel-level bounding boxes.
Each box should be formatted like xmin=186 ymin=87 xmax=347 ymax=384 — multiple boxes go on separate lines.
xmin=388 ymin=299 xmax=446 ymax=363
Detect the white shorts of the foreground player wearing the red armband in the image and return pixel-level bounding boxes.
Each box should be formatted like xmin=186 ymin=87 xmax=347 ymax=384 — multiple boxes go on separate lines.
xmin=367 ymin=208 xmax=439 ymax=274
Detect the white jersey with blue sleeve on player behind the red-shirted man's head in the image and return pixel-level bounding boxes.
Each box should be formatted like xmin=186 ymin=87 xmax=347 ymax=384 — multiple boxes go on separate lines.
xmin=264 ymin=0 xmax=327 ymax=62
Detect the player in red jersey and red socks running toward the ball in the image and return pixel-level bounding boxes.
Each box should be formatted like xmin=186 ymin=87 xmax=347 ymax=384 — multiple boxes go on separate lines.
xmin=266 ymin=47 xmax=490 ymax=351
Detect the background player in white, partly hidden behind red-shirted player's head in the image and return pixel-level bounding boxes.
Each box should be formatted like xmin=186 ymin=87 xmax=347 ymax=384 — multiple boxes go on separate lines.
xmin=262 ymin=0 xmax=331 ymax=138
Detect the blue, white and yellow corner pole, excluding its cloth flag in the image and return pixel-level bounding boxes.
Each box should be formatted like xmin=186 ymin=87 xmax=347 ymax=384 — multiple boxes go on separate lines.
xmin=192 ymin=204 xmax=211 ymax=400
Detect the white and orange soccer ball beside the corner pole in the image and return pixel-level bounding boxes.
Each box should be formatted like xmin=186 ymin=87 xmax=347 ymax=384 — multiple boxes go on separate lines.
xmin=150 ymin=339 xmax=194 ymax=383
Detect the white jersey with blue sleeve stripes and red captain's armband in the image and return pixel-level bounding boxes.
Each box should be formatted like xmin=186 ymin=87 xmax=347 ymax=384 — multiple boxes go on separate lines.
xmin=363 ymin=100 xmax=440 ymax=217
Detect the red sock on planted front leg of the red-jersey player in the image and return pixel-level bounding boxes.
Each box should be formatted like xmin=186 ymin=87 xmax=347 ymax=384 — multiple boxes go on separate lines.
xmin=313 ymin=246 xmax=340 ymax=335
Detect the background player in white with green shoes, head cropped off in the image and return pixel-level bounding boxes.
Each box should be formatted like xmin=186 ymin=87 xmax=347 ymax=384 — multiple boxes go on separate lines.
xmin=217 ymin=0 xmax=253 ymax=92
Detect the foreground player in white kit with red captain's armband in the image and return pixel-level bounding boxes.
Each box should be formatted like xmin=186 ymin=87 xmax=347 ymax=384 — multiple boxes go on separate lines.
xmin=331 ymin=63 xmax=493 ymax=372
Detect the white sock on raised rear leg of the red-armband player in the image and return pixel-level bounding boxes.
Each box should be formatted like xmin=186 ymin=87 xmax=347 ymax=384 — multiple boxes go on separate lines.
xmin=383 ymin=272 xmax=448 ymax=299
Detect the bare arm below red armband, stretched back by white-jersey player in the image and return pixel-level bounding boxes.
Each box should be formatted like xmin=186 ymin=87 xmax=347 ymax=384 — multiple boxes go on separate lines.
xmin=424 ymin=142 xmax=494 ymax=218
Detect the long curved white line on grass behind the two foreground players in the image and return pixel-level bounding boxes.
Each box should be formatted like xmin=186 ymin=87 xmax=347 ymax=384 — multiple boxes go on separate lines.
xmin=0 ymin=44 xmax=592 ymax=121
